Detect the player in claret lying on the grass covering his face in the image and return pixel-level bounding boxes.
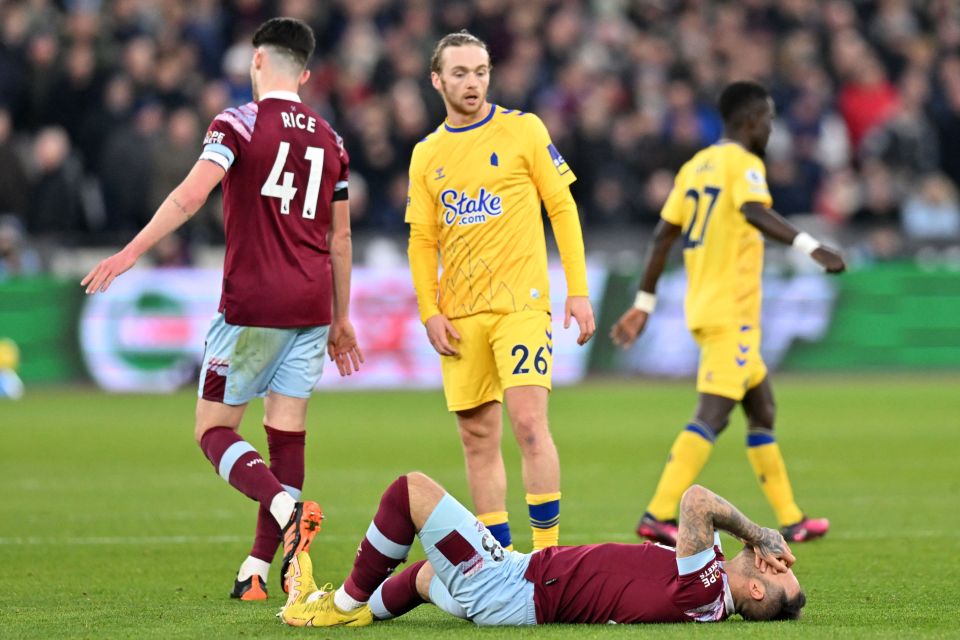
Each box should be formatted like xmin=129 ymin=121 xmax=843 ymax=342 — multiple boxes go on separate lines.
xmin=278 ymin=472 xmax=806 ymax=627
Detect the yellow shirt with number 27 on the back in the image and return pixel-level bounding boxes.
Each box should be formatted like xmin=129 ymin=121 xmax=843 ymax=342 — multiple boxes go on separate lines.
xmin=660 ymin=141 xmax=773 ymax=329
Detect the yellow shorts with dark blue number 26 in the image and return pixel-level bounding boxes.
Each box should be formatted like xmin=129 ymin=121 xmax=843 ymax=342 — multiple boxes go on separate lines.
xmin=440 ymin=311 xmax=553 ymax=411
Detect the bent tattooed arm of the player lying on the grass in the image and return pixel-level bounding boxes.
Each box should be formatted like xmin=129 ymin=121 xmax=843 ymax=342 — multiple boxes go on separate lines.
xmin=677 ymin=485 xmax=796 ymax=572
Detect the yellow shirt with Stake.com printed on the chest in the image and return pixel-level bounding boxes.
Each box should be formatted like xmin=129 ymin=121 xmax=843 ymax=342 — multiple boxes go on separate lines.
xmin=405 ymin=105 xmax=585 ymax=318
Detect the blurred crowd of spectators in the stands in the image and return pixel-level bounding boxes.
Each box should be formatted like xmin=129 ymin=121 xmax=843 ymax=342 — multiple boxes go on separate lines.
xmin=0 ymin=0 xmax=960 ymax=277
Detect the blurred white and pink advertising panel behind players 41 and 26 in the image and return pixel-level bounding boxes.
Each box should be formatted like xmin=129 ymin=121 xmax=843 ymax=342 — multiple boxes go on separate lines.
xmin=80 ymin=267 xmax=606 ymax=393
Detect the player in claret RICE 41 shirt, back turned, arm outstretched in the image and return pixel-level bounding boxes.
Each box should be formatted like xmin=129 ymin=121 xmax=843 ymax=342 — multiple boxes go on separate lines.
xmin=81 ymin=18 xmax=363 ymax=600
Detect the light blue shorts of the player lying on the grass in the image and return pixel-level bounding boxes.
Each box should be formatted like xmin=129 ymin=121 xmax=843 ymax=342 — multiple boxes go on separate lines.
xmin=419 ymin=494 xmax=537 ymax=626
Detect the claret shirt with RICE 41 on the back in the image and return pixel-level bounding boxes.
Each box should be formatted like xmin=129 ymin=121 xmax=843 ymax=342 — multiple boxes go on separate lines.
xmin=200 ymin=91 xmax=349 ymax=327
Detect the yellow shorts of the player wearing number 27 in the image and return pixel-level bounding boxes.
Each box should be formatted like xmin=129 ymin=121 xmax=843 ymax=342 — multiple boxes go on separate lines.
xmin=693 ymin=324 xmax=767 ymax=401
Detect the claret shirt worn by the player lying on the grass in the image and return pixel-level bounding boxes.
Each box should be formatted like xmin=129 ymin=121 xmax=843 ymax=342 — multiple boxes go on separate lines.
xmin=525 ymin=535 xmax=734 ymax=624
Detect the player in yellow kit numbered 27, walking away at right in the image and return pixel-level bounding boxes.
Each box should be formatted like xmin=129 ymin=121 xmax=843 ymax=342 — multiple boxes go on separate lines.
xmin=611 ymin=82 xmax=846 ymax=545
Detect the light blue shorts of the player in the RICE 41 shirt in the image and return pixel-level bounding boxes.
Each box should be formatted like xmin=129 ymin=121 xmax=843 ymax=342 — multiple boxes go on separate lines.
xmin=197 ymin=313 xmax=329 ymax=405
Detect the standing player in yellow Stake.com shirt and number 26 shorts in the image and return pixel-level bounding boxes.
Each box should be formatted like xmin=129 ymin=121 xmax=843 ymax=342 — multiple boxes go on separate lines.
xmin=406 ymin=31 xmax=596 ymax=549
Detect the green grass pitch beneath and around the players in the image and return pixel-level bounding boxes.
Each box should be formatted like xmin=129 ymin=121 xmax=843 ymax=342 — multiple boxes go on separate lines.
xmin=0 ymin=375 xmax=960 ymax=639
